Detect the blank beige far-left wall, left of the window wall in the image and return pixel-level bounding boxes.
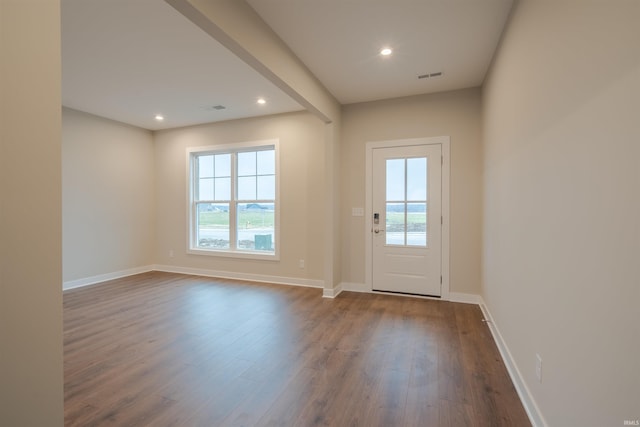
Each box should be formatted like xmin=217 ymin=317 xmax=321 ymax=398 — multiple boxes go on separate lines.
xmin=62 ymin=108 xmax=155 ymax=282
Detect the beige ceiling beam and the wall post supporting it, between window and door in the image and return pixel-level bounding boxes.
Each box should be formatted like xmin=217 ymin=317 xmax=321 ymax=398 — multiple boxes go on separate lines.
xmin=166 ymin=0 xmax=342 ymax=296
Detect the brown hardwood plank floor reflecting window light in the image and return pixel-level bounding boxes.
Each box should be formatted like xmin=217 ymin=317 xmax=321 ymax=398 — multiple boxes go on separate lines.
xmin=64 ymin=272 xmax=530 ymax=427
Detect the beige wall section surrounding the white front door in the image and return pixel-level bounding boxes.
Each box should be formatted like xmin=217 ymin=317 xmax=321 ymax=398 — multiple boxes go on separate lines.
xmin=341 ymin=89 xmax=482 ymax=294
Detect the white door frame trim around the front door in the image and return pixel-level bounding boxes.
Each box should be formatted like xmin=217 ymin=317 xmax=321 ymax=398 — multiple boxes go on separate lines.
xmin=364 ymin=136 xmax=451 ymax=301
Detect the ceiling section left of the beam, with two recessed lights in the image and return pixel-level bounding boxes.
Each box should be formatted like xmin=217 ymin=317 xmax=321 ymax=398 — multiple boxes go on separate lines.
xmin=62 ymin=0 xmax=302 ymax=130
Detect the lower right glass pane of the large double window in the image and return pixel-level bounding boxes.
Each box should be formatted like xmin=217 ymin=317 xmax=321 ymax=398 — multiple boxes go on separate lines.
xmin=237 ymin=203 xmax=276 ymax=252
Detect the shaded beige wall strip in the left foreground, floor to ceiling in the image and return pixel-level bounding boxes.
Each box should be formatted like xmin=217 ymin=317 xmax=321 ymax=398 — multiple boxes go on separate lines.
xmin=0 ymin=0 xmax=63 ymax=427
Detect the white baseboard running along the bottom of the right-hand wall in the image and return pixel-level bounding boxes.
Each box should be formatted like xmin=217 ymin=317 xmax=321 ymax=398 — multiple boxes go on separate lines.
xmin=479 ymin=297 xmax=547 ymax=427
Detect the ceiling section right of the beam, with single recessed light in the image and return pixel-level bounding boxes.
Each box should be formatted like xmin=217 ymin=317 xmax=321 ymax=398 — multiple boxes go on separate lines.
xmin=248 ymin=0 xmax=512 ymax=104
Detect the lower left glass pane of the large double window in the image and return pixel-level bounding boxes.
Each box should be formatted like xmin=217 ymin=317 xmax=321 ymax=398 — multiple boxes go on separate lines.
xmin=196 ymin=203 xmax=230 ymax=249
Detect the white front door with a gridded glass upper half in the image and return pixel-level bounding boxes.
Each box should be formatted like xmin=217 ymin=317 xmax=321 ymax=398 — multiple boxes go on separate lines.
xmin=371 ymin=144 xmax=442 ymax=296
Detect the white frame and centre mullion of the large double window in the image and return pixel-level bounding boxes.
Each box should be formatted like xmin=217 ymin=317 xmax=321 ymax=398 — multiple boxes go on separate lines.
xmin=186 ymin=139 xmax=282 ymax=261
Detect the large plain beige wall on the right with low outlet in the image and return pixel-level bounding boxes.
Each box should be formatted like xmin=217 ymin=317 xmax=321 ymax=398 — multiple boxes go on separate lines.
xmin=483 ymin=0 xmax=640 ymax=426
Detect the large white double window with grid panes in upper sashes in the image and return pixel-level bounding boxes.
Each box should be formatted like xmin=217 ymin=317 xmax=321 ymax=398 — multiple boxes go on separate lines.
xmin=188 ymin=141 xmax=279 ymax=259
